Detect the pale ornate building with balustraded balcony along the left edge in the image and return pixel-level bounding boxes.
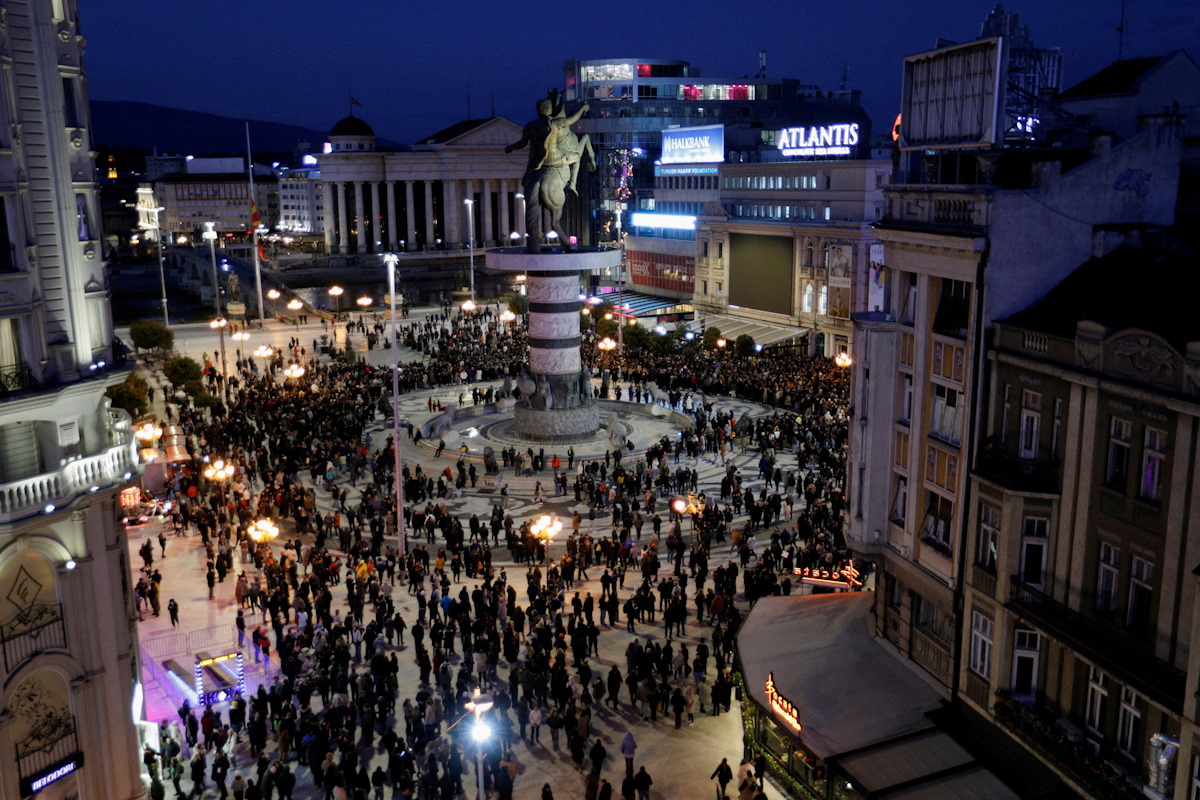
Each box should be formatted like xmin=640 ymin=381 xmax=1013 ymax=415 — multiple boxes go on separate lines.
xmin=0 ymin=0 xmax=144 ymax=798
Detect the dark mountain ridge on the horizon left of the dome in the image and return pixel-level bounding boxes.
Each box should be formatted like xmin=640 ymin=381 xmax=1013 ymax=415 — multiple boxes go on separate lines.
xmin=91 ymin=100 xmax=408 ymax=156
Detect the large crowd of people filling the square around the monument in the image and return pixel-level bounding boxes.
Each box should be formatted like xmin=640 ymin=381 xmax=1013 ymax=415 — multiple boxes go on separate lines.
xmin=136 ymin=308 xmax=847 ymax=800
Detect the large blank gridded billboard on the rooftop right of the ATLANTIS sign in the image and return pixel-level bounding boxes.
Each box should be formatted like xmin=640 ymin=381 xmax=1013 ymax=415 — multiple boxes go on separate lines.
xmin=900 ymin=37 xmax=1007 ymax=150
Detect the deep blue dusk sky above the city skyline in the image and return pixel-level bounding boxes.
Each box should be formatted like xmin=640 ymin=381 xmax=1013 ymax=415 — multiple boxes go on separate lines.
xmin=79 ymin=0 xmax=1200 ymax=143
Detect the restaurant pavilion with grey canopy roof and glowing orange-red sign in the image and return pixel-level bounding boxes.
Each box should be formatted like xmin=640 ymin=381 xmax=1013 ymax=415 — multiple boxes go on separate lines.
xmin=738 ymin=591 xmax=1018 ymax=800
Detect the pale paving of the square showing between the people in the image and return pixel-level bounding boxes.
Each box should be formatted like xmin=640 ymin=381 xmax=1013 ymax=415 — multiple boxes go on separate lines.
xmin=128 ymin=309 xmax=835 ymax=800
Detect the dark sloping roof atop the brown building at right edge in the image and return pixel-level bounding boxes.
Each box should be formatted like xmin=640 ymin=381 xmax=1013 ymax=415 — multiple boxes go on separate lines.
xmin=1001 ymin=241 xmax=1200 ymax=353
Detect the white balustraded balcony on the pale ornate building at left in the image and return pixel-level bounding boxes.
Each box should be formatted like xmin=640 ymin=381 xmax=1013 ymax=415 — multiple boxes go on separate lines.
xmin=0 ymin=411 xmax=138 ymax=524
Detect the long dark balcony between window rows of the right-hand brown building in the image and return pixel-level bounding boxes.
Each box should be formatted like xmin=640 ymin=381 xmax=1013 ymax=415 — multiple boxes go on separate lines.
xmin=1007 ymin=576 xmax=1187 ymax=714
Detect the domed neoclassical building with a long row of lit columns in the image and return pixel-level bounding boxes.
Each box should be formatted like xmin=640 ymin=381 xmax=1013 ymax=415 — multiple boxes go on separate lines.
xmin=319 ymin=116 xmax=526 ymax=254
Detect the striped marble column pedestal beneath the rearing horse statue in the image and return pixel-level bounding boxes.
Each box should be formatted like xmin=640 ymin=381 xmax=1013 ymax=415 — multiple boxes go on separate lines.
xmin=486 ymin=247 xmax=620 ymax=441
